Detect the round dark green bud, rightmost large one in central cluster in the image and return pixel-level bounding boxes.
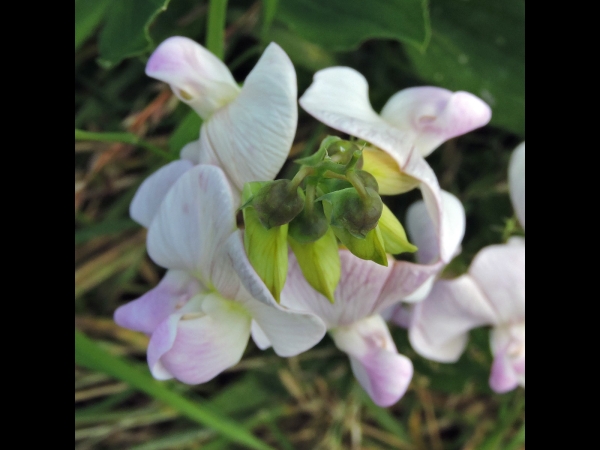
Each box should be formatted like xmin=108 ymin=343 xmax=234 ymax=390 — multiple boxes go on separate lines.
xmin=320 ymin=187 xmax=383 ymax=239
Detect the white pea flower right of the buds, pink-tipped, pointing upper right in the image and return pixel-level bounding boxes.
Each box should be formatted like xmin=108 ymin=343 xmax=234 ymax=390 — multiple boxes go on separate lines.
xmin=300 ymin=67 xmax=491 ymax=261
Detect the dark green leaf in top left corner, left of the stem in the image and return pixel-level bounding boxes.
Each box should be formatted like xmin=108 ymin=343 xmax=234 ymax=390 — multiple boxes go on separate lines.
xmin=98 ymin=0 xmax=170 ymax=69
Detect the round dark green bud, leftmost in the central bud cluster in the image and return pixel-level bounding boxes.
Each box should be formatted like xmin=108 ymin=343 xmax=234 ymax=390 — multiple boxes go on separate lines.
xmin=251 ymin=180 xmax=304 ymax=230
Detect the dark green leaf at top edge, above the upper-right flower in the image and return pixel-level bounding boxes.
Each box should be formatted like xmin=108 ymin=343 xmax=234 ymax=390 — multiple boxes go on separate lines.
xmin=276 ymin=0 xmax=430 ymax=50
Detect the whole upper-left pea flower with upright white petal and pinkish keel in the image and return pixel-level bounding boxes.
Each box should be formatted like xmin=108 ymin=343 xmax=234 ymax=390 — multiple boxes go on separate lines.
xmin=130 ymin=36 xmax=298 ymax=227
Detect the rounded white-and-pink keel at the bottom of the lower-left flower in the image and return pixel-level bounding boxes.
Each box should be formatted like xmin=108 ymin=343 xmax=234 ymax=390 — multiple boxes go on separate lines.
xmin=148 ymin=295 xmax=251 ymax=384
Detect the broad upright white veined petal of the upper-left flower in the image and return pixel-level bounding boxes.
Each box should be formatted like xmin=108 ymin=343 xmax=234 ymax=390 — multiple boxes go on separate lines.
xmin=200 ymin=43 xmax=298 ymax=192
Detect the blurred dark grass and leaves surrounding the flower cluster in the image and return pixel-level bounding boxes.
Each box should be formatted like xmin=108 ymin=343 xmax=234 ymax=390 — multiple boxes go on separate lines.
xmin=75 ymin=0 xmax=525 ymax=450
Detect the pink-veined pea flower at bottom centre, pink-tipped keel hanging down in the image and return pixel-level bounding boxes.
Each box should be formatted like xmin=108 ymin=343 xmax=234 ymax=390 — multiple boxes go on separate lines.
xmin=253 ymin=192 xmax=465 ymax=406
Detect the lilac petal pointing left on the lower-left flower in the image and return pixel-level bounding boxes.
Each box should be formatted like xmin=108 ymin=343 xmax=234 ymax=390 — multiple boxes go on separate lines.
xmin=114 ymin=270 xmax=204 ymax=334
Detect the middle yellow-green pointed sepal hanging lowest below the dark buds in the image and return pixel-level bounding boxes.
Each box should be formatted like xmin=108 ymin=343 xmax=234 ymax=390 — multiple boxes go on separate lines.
xmin=288 ymin=228 xmax=342 ymax=303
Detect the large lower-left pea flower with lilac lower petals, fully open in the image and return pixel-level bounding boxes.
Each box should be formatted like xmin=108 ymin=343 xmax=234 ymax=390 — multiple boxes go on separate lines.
xmin=115 ymin=165 xmax=325 ymax=384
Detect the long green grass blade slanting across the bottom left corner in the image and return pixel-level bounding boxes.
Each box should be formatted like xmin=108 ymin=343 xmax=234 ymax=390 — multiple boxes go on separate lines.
xmin=75 ymin=330 xmax=271 ymax=450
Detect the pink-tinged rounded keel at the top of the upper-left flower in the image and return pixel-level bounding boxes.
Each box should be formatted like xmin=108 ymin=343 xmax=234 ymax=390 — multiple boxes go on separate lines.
xmin=146 ymin=36 xmax=240 ymax=120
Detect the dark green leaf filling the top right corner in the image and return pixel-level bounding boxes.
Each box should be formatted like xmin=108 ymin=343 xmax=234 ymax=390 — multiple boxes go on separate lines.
xmin=407 ymin=0 xmax=525 ymax=136
